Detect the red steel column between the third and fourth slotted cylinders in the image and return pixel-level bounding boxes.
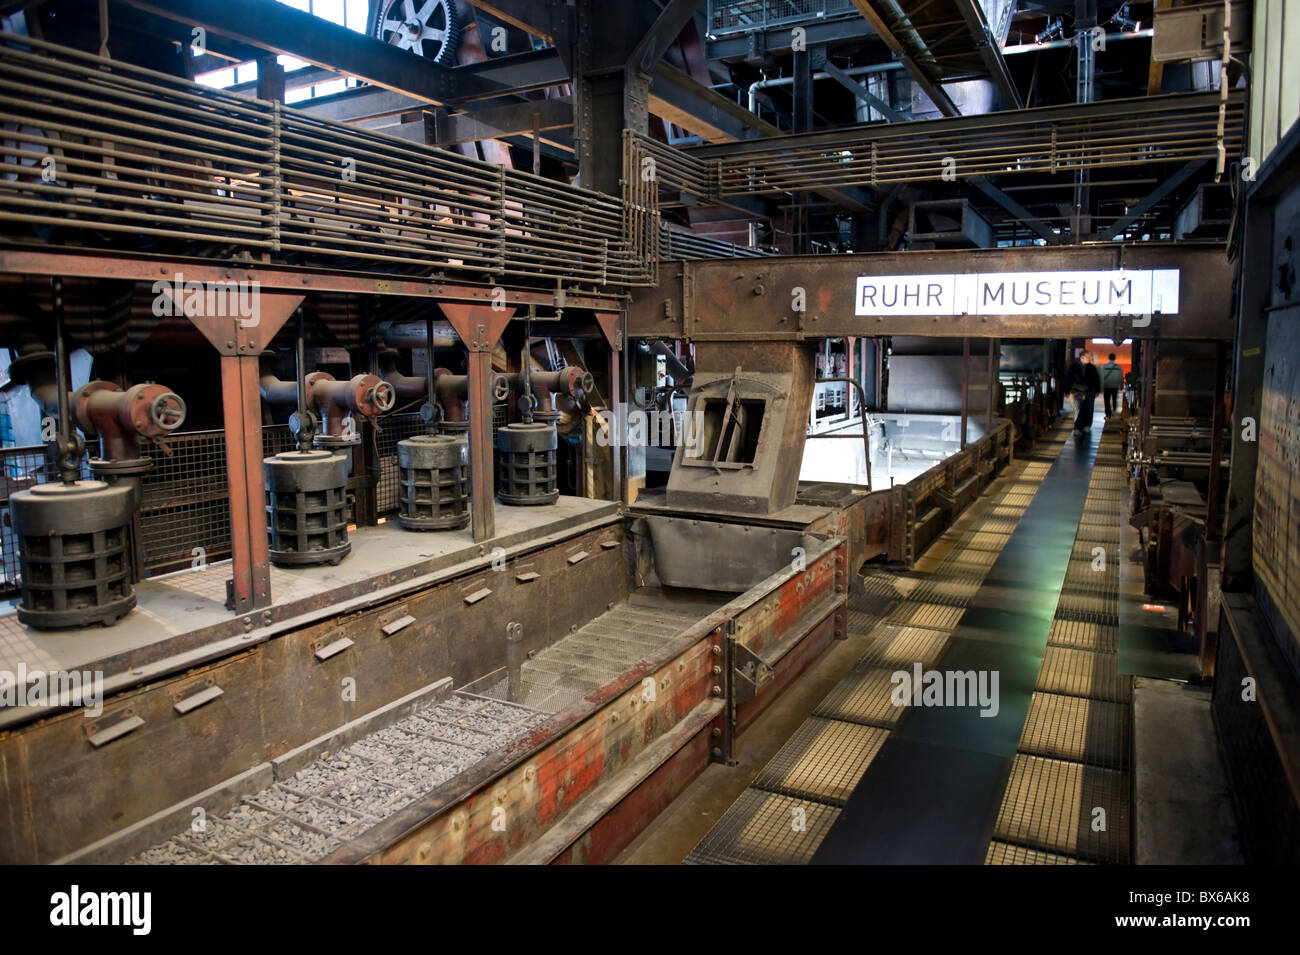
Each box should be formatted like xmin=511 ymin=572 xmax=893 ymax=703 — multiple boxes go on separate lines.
xmin=438 ymin=301 xmax=515 ymax=542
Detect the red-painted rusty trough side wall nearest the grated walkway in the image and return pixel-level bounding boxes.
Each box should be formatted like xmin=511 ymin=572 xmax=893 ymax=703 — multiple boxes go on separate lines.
xmin=326 ymin=538 xmax=844 ymax=864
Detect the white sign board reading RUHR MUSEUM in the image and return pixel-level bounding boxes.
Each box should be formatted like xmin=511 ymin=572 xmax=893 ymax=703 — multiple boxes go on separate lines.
xmin=854 ymin=269 xmax=1178 ymax=316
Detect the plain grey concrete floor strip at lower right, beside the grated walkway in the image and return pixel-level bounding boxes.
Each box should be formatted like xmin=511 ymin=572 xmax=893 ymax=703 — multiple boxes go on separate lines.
xmin=1134 ymin=677 xmax=1245 ymax=865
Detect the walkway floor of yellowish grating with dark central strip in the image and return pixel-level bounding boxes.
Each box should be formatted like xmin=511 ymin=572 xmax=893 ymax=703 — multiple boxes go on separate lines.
xmin=686 ymin=416 xmax=1131 ymax=864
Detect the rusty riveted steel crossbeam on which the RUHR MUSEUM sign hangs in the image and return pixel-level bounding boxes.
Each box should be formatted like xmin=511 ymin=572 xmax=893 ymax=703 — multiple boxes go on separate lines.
xmin=627 ymin=243 xmax=1234 ymax=342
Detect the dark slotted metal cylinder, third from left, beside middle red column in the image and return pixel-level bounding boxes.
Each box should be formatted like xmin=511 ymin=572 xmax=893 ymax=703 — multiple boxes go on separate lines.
xmin=398 ymin=434 xmax=469 ymax=530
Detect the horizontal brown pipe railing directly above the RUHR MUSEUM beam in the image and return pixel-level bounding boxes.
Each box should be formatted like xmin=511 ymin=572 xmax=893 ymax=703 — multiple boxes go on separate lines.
xmin=624 ymin=92 xmax=1244 ymax=213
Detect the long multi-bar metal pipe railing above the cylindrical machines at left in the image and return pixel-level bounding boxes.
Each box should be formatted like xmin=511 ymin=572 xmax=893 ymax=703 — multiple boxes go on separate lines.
xmin=0 ymin=34 xmax=653 ymax=286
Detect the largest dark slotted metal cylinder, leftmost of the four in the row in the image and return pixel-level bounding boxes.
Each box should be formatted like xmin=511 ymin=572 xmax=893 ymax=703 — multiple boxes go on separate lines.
xmin=9 ymin=481 xmax=135 ymax=630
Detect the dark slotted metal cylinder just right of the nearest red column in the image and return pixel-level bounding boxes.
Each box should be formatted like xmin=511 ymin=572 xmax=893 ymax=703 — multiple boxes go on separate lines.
xmin=263 ymin=450 xmax=352 ymax=567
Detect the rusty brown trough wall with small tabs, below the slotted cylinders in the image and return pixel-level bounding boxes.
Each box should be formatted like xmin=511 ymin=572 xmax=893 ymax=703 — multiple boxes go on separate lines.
xmin=0 ymin=524 xmax=624 ymax=863
